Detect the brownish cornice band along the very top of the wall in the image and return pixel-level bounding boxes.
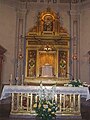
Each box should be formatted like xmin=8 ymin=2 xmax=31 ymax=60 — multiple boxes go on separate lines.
xmin=0 ymin=0 xmax=89 ymax=7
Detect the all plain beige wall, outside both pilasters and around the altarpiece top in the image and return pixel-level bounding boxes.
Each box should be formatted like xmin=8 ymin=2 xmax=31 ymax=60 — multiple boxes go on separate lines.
xmin=0 ymin=1 xmax=90 ymax=84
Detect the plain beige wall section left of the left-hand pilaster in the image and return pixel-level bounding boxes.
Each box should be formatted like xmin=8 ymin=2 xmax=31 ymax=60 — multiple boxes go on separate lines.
xmin=0 ymin=3 xmax=16 ymax=84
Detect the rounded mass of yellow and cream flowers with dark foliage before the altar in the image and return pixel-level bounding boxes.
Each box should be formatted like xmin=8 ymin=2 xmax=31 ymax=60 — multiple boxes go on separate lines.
xmin=34 ymin=99 xmax=57 ymax=120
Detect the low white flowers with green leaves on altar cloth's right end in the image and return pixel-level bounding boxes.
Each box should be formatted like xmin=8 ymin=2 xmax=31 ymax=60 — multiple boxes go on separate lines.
xmin=64 ymin=79 xmax=83 ymax=87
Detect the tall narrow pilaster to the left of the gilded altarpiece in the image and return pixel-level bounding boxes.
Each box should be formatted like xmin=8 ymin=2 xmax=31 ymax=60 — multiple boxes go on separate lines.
xmin=15 ymin=9 xmax=27 ymax=84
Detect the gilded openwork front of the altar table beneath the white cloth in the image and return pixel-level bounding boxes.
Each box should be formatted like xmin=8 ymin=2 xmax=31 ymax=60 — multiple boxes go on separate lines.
xmin=11 ymin=93 xmax=80 ymax=115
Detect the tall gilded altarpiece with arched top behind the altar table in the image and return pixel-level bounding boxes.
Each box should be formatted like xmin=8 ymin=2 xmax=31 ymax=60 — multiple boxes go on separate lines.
xmin=25 ymin=8 xmax=69 ymax=84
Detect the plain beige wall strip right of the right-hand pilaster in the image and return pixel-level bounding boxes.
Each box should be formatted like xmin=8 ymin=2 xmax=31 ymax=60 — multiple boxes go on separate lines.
xmin=80 ymin=4 xmax=90 ymax=84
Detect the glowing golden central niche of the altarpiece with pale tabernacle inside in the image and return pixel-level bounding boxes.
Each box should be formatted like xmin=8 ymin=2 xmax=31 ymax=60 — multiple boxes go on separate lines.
xmin=39 ymin=51 xmax=56 ymax=77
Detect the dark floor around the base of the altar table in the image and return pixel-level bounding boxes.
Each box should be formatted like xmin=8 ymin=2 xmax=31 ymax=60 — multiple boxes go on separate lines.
xmin=0 ymin=99 xmax=90 ymax=120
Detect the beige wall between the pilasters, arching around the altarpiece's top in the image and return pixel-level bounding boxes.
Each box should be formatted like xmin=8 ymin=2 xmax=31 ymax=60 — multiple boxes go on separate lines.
xmin=26 ymin=3 xmax=70 ymax=32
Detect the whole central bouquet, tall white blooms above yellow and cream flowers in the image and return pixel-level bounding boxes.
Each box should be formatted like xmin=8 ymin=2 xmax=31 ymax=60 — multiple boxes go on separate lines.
xmin=33 ymin=83 xmax=57 ymax=120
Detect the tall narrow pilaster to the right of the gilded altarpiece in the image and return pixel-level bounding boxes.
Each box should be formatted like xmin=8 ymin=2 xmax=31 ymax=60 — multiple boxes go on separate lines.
xmin=70 ymin=3 xmax=80 ymax=79
